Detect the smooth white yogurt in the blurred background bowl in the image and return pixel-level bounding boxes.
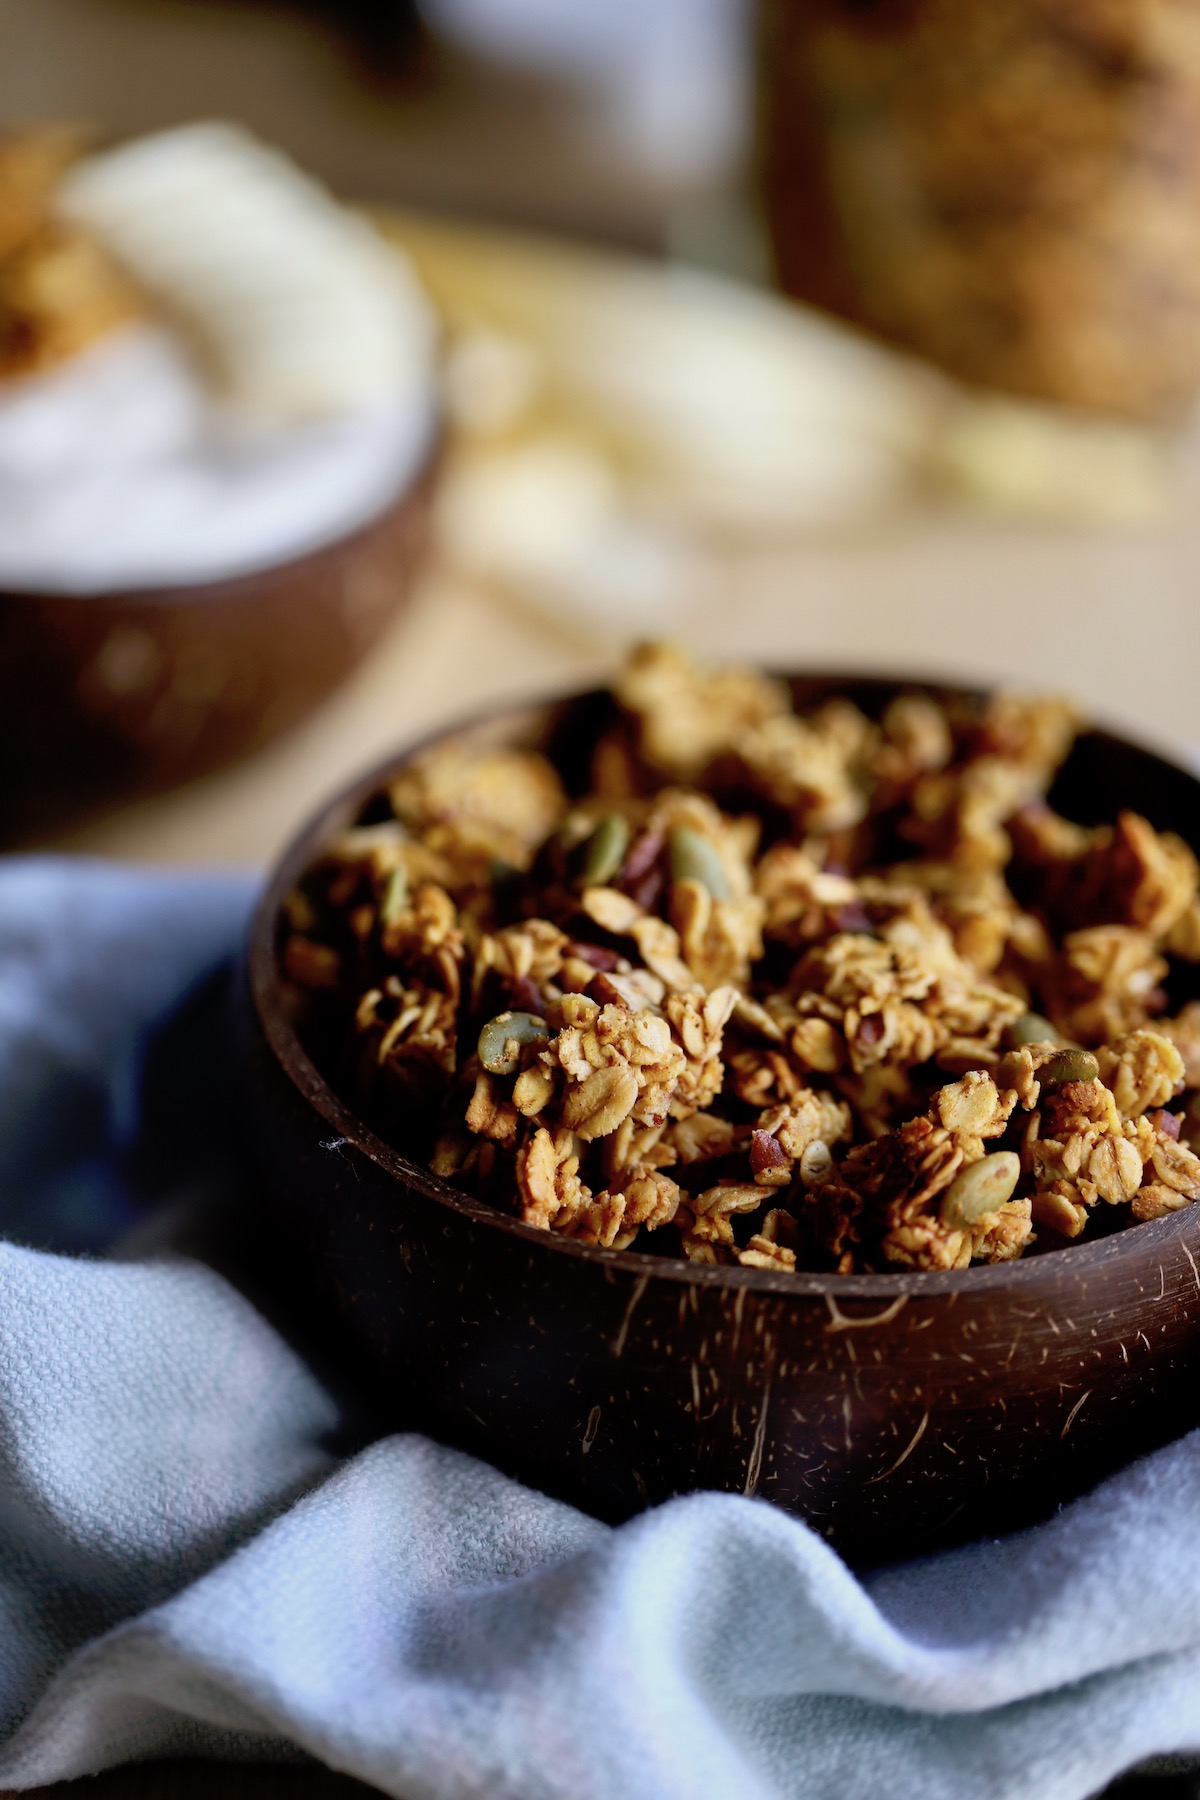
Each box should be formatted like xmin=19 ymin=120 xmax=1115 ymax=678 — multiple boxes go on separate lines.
xmin=0 ymin=326 xmax=435 ymax=594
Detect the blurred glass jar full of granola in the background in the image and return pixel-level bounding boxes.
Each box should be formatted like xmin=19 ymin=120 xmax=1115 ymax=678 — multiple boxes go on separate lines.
xmin=759 ymin=0 xmax=1200 ymax=418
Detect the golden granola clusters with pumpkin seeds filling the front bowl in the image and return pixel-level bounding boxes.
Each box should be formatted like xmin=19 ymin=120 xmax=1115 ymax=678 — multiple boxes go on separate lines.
xmin=281 ymin=646 xmax=1200 ymax=1273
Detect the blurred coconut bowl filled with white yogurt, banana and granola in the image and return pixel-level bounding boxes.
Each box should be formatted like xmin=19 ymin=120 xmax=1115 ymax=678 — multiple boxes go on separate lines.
xmin=0 ymin=124 xmax=439 ymax=841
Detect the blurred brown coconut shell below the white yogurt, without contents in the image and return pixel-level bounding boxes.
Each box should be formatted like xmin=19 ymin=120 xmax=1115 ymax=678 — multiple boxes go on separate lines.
xmin=0 ymin=454 xmax=435 ymax=842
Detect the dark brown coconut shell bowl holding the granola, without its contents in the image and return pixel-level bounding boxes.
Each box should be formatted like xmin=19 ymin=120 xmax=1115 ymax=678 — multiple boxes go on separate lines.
xmin=248 ymin=677 xmax=1200 ymax=1561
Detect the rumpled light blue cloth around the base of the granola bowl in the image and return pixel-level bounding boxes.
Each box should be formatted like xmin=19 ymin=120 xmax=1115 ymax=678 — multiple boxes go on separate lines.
xmin=0 ymin=860 xmax=1200 ymax=1800
